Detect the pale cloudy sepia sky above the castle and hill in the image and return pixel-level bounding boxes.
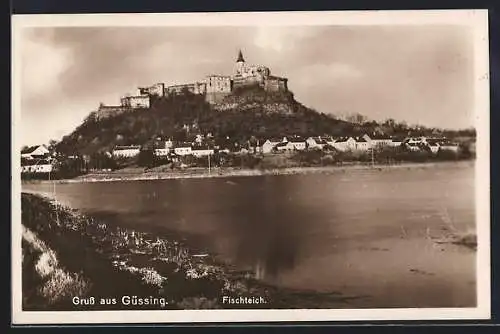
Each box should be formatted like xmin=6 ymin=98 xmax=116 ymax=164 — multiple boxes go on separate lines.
xmin=19 ymin=25 xmax=474 ymax=145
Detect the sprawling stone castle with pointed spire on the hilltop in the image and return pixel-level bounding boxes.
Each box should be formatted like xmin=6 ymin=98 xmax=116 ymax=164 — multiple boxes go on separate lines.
xmin=97 ymin=50 xmax=288 ymax=118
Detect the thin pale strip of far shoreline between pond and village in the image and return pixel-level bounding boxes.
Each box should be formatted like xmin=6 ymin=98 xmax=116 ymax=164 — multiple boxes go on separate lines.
xmin=21 ymin=160 xmax=475 ymax=184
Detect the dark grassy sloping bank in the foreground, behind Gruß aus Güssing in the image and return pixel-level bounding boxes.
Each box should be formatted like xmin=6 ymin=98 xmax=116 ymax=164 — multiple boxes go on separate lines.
xmin=22 ymin=193 xmax=356 ymax=310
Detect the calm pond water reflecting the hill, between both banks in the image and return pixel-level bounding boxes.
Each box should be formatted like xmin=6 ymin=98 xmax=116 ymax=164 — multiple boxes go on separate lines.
xmin=23 ymin=165 xmax=476 ymax=307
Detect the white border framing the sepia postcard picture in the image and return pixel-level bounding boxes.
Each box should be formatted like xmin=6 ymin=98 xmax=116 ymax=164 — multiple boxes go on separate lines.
xmin=11 ymin=10 xmax=491 ymax=325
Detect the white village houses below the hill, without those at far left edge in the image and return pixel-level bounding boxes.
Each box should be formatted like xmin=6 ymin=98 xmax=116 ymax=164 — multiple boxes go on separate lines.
xmin=112 ymin=134 xmax=458 ymax=158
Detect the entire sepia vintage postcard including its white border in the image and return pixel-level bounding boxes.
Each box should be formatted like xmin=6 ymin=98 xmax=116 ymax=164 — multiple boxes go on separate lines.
xmin=12 ymin=10 xmax=490 ymax=324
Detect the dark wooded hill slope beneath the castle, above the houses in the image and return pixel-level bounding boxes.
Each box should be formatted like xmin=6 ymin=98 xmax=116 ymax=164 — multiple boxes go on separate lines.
xmin=56 ymin=87 xmax=472 ymax=154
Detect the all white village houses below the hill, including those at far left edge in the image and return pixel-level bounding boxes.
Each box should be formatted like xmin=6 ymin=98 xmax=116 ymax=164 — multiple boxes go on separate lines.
xmin=21 ymin=134 xmax=459 ymax=173
